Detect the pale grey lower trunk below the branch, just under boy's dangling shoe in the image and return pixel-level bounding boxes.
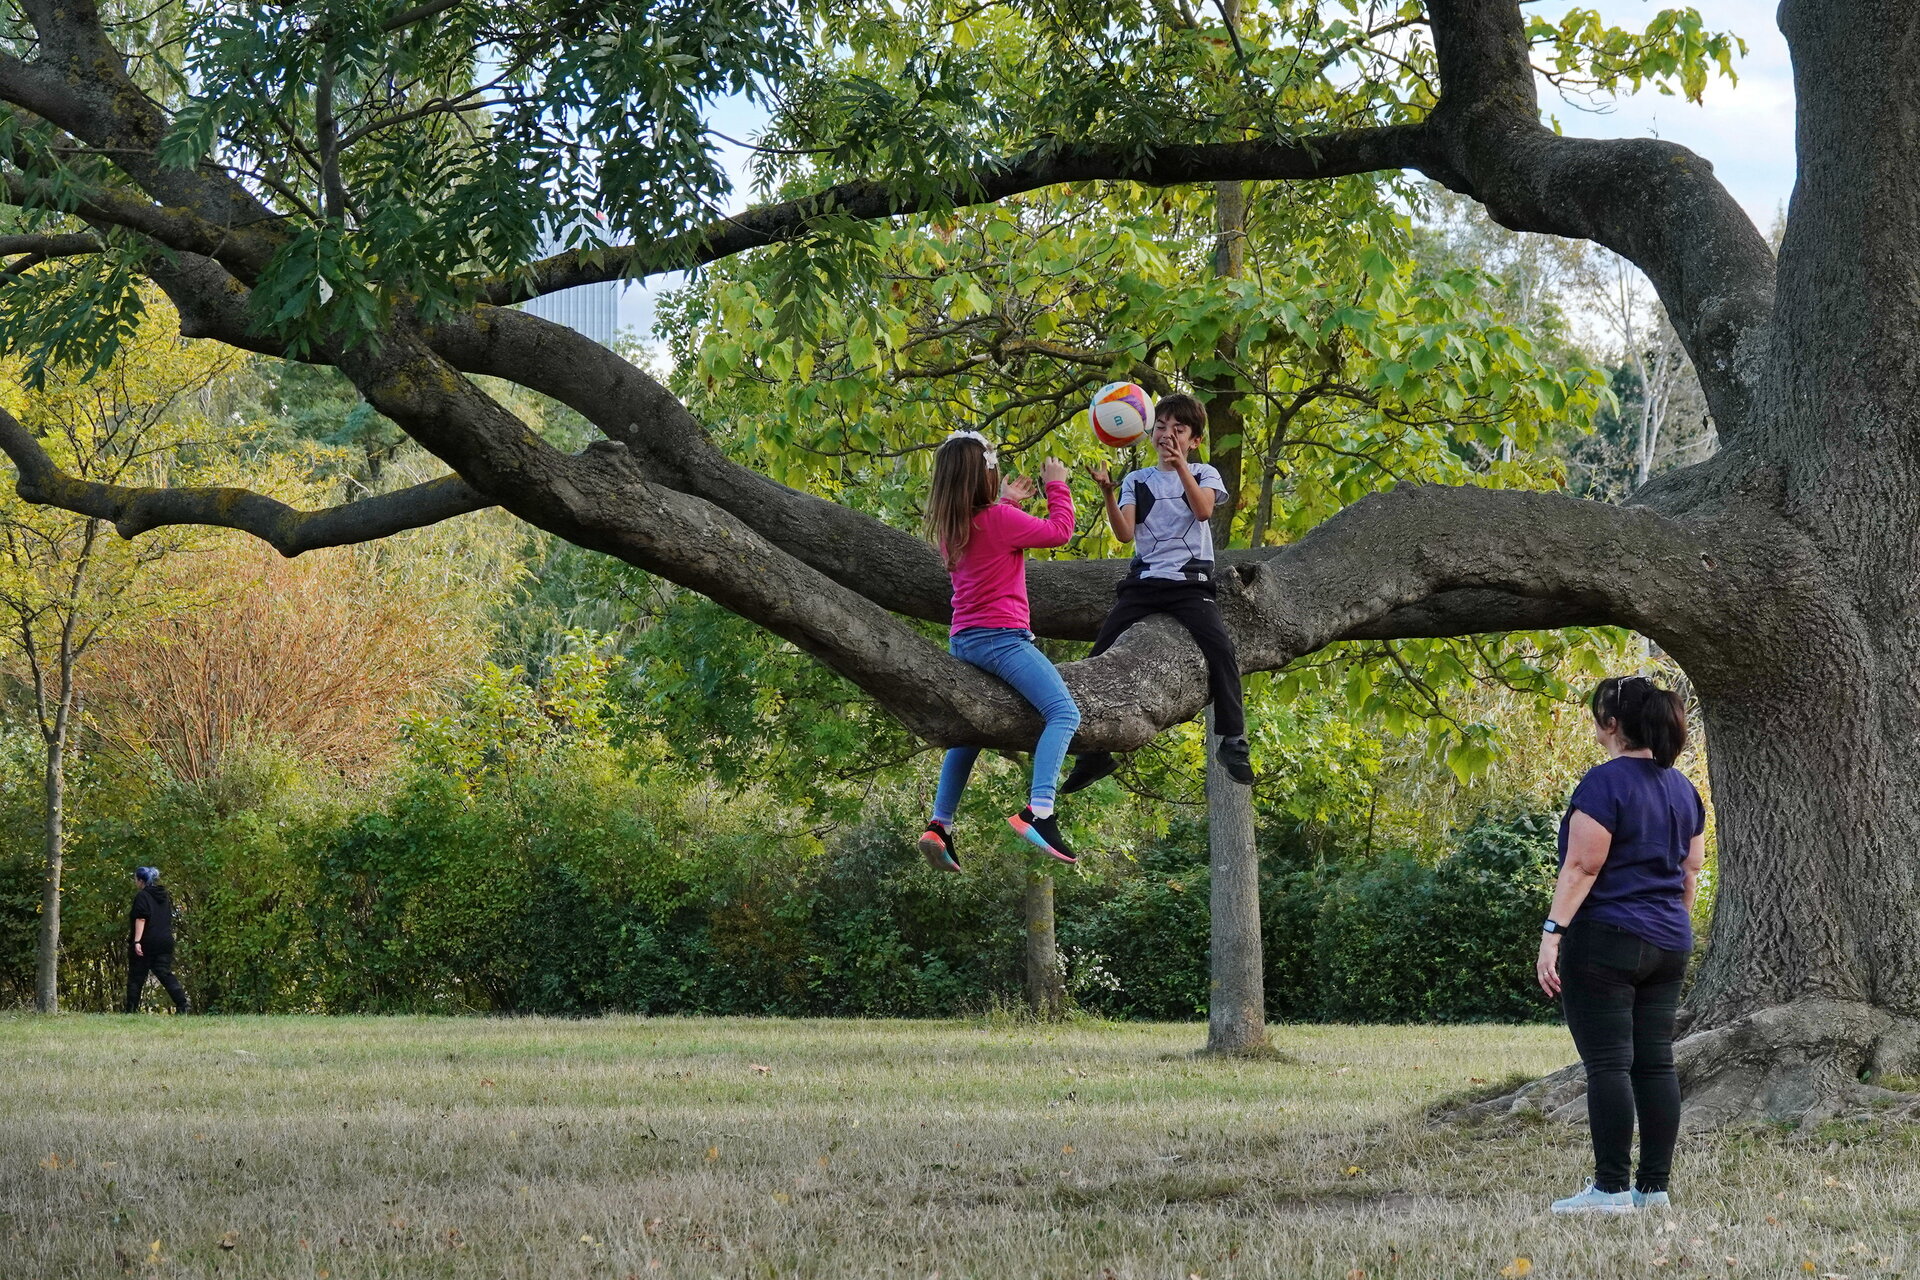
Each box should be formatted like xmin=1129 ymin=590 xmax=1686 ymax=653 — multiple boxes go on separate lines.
xmin=1206 ymin=708 xmax=1271 ymax=1054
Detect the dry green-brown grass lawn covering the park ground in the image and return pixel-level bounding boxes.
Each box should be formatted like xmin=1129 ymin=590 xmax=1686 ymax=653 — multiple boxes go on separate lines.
xmin=0 ymin=1015 xmax=1920 ymax=1280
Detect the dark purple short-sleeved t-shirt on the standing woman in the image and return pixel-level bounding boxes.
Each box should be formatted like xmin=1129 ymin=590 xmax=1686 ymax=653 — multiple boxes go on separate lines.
xmin=1561 ymin=756 xmax=1707 ymax=952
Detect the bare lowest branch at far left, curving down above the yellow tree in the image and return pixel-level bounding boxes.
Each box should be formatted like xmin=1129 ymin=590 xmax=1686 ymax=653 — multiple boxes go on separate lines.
xmin=0 ymin=409 xmax=493 ymax=557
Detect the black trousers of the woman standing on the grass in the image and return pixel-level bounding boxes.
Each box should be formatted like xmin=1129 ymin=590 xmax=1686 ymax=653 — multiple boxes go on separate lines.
xmin=1561 ymin=921 xmax=1686 ymax=1192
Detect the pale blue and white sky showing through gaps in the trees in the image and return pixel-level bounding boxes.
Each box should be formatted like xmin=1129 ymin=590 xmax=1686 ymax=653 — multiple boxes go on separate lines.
xmin=620 ymin=0 xmax=1797 ymax=334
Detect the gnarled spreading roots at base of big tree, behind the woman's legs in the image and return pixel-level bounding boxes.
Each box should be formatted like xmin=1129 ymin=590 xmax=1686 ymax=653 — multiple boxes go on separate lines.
xmin=1434 ymin=1000 xmax=1920 ymax=1132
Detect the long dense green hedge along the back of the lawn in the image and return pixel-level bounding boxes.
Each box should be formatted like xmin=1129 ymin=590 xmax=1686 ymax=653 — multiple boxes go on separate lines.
xmin=0 ymin=748 xmax=1553 ymax=1021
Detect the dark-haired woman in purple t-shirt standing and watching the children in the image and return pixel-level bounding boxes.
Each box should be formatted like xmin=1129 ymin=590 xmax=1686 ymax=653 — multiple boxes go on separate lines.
xmin=1536 ymin=676 xmax=1707 ymax=1213
